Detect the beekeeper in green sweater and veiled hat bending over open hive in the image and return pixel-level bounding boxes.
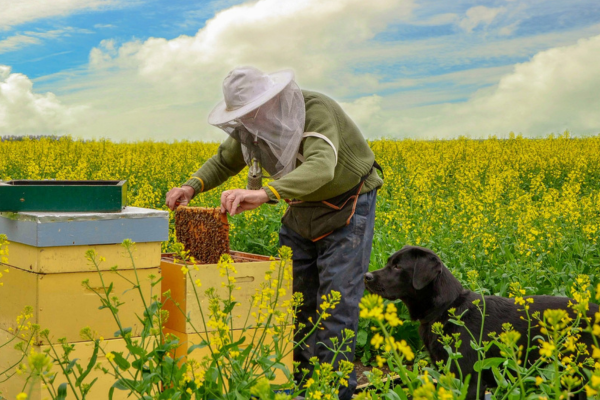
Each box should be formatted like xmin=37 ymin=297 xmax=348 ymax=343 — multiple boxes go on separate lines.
xmin=166 ymin=67 xmax=383 ymax=400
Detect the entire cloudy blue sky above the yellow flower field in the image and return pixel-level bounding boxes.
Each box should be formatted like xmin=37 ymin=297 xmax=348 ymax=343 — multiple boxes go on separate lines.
xmin=0 ymin=0 xmax=600 ymax=141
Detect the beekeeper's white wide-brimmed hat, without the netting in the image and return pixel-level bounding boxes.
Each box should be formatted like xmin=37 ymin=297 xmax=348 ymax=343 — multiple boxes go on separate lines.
xmin=208 ymin=67 xmax=294 ymax=125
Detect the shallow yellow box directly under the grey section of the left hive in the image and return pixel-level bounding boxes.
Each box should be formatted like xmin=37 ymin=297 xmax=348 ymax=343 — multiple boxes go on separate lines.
xmin=8 ymin=242 xmax=161 ymax=274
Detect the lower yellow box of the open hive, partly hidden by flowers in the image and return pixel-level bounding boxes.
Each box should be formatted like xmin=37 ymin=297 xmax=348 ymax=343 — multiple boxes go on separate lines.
xmin=163 ymin=327 xmax=294 ymax=385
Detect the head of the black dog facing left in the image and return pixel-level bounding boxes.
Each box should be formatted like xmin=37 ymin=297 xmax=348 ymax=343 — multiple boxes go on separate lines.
xmin=365 ymin=246 xmax=462 ymax=319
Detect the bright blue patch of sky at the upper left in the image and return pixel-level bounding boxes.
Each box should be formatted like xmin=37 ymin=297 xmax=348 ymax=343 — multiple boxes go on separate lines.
xmin=0 ymin=0 xmax=241 ymax=79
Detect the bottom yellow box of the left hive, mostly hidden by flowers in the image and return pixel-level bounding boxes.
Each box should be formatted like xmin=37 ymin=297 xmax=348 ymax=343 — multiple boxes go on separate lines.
xmin=0 ymin=330 xmax=128 ymax=400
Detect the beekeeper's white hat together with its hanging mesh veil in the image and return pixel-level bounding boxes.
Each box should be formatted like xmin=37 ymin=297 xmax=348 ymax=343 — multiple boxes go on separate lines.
xmin=208 ymin=67 xmax=306 ymax=179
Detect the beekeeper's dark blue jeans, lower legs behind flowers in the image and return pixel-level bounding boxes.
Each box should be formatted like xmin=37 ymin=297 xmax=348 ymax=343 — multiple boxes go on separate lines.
xmin=279 ymin=190 xmax=377 ymax=400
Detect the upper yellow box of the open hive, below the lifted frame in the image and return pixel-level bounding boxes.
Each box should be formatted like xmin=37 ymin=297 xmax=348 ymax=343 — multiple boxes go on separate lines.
xmin=160 ymin=251 xmax=292 ymax=333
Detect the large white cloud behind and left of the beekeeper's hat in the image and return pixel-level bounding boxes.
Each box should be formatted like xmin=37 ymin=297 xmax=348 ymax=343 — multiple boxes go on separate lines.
xmin=32 ymin=0 xmax=413 ymax=140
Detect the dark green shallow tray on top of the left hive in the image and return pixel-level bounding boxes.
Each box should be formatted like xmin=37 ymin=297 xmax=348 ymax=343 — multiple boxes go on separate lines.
xmin=0 ymin=180 xmax=127 ymax=212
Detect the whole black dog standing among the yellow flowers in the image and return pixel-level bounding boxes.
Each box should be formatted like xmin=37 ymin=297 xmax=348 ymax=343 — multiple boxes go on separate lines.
xmin=365 ymin=246 xmax=598 ymax=399
